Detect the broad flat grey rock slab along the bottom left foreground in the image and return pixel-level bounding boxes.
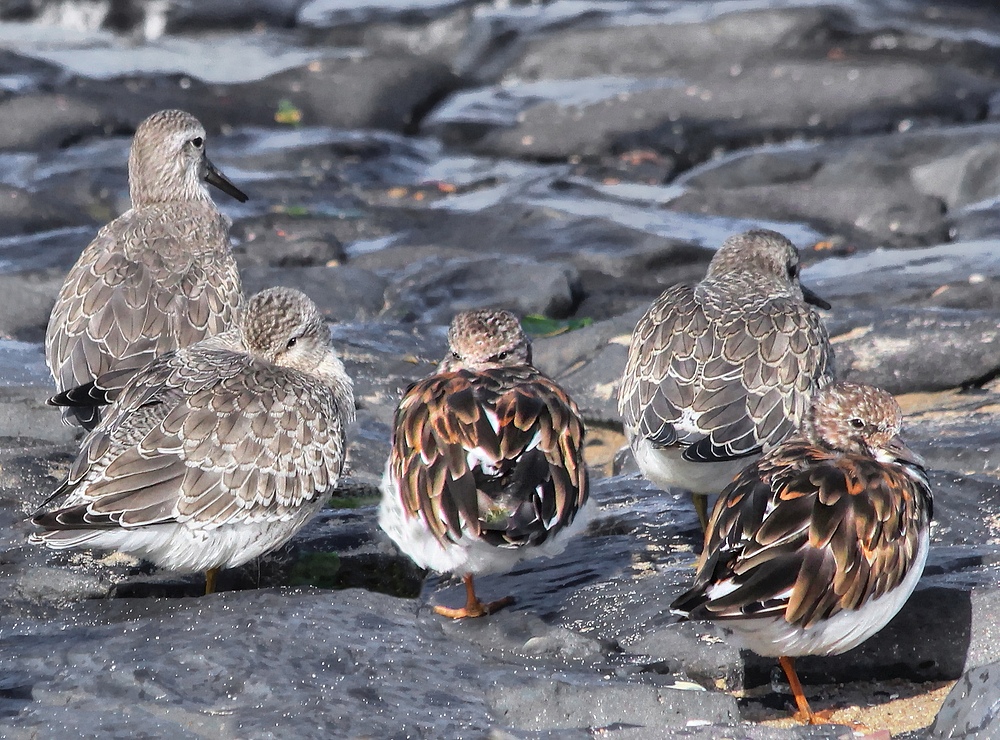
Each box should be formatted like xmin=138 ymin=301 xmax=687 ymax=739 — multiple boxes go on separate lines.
xmin=0 ymin=590 xmax=737 ymax=737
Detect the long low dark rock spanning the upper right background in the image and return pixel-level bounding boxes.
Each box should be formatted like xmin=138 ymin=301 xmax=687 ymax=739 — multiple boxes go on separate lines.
xmin=422 ymin=61 xmax=989 ymax=163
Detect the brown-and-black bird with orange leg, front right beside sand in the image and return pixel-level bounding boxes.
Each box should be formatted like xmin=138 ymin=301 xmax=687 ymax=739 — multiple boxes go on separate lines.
xmin=671 ymin=383 xmax=932 ymax=724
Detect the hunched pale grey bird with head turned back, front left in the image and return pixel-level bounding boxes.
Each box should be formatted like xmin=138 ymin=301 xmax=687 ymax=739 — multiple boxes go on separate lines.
xmin=31 ymin=288 xmax=354 ymax=593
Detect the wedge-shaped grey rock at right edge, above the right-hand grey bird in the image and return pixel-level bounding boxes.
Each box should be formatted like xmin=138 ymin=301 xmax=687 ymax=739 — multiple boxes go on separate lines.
xmin=669 ymin=123 xmax=1000 ymax=248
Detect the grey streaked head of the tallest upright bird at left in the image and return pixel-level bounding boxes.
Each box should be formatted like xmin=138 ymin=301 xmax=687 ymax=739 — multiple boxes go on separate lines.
xmin=128 ymin=110 xmax=210 ymax=207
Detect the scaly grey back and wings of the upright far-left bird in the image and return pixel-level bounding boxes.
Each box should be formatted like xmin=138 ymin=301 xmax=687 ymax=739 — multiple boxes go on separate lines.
xmin=45 ymin=208 xmax=243 ymax=424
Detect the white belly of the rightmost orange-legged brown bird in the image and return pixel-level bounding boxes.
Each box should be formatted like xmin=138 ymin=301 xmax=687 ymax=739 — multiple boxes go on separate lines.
xmin=723 ymin=532 xmax=930 ymax=658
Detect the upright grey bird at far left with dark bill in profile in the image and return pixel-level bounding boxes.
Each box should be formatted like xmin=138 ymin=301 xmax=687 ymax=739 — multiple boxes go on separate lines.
xmin=45 ymin=110 xmax=247 ymax=429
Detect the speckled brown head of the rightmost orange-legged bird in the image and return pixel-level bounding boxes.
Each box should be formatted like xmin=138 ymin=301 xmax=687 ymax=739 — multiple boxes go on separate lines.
xmin=802 ymin=383 xmax=903 ymax=455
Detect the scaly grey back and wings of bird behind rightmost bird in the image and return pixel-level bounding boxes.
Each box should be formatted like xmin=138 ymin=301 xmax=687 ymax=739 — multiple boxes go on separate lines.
xmin=619 ymin=286 xmax=833 ymax=461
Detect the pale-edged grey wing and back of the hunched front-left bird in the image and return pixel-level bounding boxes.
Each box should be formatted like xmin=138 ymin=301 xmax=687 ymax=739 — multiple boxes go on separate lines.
xmin=37 ymin=348 xmax=353 ymax=528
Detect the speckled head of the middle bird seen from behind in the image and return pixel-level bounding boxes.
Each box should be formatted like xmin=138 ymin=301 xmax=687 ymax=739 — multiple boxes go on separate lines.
xmin=441 ymin=308 xmax=531 ymax=371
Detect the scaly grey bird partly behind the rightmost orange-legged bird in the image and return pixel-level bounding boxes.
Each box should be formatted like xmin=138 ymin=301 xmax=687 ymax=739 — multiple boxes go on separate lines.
xmin=618 ymin=230 xmax=833 ymax=529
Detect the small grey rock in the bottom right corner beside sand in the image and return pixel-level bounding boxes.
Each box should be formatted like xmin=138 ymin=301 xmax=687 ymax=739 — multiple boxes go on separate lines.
xmin=928 ymin=663 xmax=1000 ymax=740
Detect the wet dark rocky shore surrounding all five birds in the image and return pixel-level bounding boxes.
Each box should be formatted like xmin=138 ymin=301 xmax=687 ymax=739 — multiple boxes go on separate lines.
xmin=0 ymin=0 xmax=1000 ymax=740
